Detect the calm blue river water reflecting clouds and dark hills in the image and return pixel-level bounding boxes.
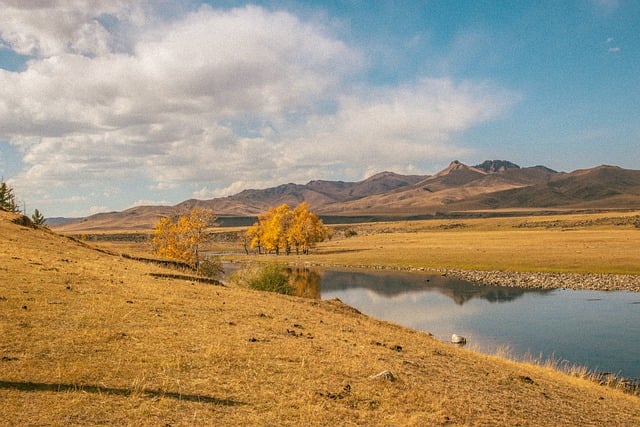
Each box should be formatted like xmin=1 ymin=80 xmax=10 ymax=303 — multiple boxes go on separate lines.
xmin=318 ymin=271 xmax=640 ymax=378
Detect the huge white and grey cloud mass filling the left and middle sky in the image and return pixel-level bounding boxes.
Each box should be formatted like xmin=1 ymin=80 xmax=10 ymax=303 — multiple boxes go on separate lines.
xmin=0 ymin=0 xmax=517 ymax=214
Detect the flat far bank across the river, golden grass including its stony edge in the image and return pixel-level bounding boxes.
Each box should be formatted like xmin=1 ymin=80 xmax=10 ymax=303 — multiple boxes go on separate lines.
xmin=215 ymin=212 xmax=640 ymax=292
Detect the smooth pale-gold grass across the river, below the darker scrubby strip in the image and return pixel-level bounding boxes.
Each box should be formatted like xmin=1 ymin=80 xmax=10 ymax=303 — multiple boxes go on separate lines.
xmin=309 ymin=230 xmax=640 ymax=274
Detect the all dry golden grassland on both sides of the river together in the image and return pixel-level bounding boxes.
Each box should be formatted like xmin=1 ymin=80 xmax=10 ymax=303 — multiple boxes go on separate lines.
xmin=0 ymin=212 xmax=640 ymax=425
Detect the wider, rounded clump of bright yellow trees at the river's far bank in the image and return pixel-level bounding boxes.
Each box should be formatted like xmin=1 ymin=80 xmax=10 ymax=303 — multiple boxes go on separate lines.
xmin=247 ymin=202 xmax=329 ymax=255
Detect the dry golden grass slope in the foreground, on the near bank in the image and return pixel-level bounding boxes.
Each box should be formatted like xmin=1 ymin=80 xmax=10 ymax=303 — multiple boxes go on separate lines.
xmin=0 ymin=213 xmax=640 ymax=426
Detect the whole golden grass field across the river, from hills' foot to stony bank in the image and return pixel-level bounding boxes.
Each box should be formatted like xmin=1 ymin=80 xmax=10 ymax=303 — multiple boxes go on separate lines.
xmin=225 ymin=212 xmax=640 ymax=274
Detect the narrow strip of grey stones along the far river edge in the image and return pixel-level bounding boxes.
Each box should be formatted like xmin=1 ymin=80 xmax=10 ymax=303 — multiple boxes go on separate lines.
xmin=290 ymin=263 xmax=640 ymax=292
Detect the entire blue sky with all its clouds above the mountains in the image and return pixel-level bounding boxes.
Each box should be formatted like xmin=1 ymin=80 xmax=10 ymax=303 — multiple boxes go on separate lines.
xmin=0 ymin=0 xmax=640 ymax=217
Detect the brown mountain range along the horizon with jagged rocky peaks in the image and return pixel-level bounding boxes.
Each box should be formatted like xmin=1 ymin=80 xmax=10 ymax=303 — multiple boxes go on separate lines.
xmin=49 ymin=160 xmax=640 ymax=231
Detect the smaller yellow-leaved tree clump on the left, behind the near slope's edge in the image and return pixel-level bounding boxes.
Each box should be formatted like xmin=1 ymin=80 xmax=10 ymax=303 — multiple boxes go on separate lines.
xmin=153 ymin=208 xmax=215 ymax=267
